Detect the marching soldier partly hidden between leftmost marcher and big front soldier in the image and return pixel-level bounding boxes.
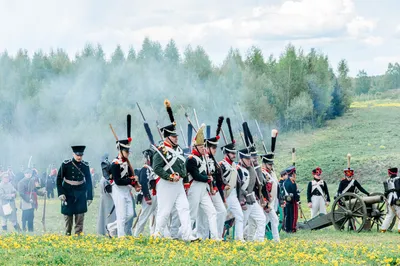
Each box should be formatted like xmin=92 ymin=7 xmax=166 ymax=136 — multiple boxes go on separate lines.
xmin=134 ymin=149 xmax=159 ymax=237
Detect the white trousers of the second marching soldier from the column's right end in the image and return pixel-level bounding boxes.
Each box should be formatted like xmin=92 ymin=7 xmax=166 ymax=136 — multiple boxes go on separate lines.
xmin=243 ymin=203 xmax=266 ymax=241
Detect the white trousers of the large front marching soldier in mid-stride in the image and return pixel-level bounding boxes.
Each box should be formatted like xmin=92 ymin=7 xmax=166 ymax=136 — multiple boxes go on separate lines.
xmin=154 ymin=179 xmax=192 ymax=241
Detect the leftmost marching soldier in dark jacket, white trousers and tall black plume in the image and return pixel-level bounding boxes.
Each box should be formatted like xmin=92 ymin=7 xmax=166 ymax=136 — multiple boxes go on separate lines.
xmin=106 ymin=114 xmax=141 ymax=237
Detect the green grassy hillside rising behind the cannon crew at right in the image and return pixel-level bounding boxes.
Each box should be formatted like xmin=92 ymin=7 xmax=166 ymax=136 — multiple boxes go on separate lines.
xmin=276 ymin=99 xmax=400 ymax=184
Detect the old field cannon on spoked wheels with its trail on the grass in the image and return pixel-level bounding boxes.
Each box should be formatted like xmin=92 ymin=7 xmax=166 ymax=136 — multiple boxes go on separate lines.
xmin=299 ymin=193 xmax=396 ymax=233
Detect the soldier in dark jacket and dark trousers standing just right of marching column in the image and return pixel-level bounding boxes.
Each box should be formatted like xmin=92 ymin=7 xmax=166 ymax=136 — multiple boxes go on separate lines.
xmin=283 ymin=166 xmax=300 ymax=233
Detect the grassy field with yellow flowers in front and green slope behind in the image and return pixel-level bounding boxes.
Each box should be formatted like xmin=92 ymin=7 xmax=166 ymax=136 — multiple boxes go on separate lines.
xmin=0 ymin=100 xmax=400 ymax=265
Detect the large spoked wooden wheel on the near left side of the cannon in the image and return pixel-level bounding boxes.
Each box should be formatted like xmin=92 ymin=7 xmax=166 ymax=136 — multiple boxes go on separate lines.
xmin=332 ymin=193 xmax=368 ymax=232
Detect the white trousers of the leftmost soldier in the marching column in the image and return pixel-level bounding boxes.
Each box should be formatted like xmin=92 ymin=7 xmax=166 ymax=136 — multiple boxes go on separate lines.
xmin=107 ymin=185 xmax=133 ymax=237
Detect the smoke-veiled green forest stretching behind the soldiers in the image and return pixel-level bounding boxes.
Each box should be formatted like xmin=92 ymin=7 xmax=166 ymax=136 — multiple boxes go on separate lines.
xmin=0 ymin=38 xmax=400 ymax=166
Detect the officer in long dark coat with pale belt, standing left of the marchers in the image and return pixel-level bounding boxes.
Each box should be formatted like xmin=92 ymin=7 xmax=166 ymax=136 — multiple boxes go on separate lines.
xmin=57 ymin=146 xmax=93 ymax=235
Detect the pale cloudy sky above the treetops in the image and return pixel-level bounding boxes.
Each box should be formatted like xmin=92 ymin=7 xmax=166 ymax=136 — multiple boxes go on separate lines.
xmin=0 ymin=0 xmax=400 ymax=76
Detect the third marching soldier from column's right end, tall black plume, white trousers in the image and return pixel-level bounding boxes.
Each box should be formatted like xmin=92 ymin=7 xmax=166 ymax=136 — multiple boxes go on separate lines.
xmin=219 ymin=117 xmax=244 ymax=241
